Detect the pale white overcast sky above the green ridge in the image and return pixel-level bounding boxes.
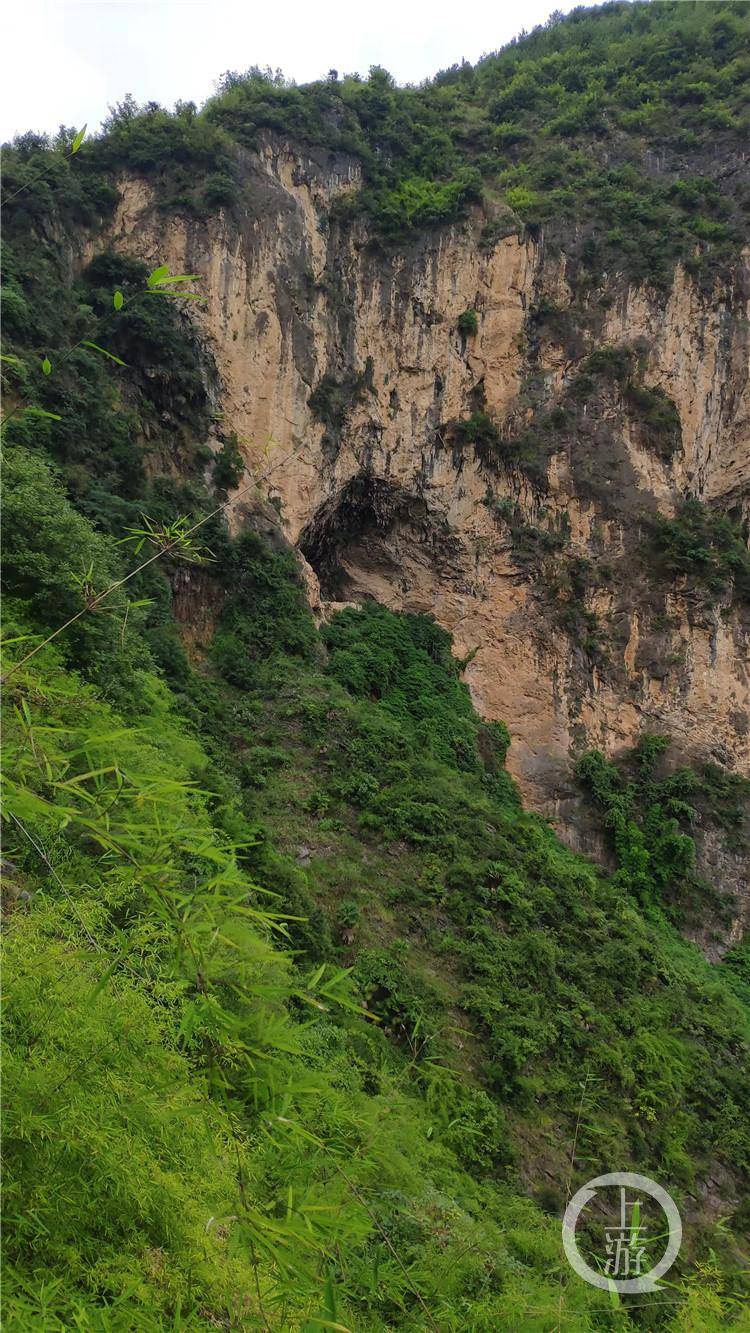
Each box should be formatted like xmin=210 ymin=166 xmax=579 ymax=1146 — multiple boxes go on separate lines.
xmin=0 ymin=0 xmax=602 ymax=140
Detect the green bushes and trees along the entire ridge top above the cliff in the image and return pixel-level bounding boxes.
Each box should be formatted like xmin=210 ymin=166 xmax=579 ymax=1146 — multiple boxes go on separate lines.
xmin=5 ymin=0 xmax=749 ymax=284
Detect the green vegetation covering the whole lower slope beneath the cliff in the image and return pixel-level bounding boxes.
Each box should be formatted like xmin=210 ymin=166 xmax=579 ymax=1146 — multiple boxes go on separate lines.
xmin=5 ymin=445 xmax=750 ymax=1329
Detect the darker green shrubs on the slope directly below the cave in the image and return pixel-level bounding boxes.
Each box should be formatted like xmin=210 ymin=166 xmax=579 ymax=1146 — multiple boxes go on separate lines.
xmin=230 ymin=607 xmax=747 ymax=1199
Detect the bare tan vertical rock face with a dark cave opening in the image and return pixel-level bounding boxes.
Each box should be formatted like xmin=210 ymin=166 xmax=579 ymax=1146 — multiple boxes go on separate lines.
xmin=97 ymin=139 xmax=750 ymax=842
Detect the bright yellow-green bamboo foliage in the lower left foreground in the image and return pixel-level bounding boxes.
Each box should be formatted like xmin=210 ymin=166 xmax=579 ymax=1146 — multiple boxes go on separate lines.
xmin=4 ymin=634 xmax=644 ymax=1333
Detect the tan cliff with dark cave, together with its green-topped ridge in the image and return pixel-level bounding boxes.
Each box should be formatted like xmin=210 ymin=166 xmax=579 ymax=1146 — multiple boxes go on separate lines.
xmin=30 ymin=4 xmax=750 ymax=906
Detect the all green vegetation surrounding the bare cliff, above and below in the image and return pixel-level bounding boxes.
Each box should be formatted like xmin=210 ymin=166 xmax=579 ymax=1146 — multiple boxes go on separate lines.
xmin=3 ymin=3 xmax=750 ymax=1333
